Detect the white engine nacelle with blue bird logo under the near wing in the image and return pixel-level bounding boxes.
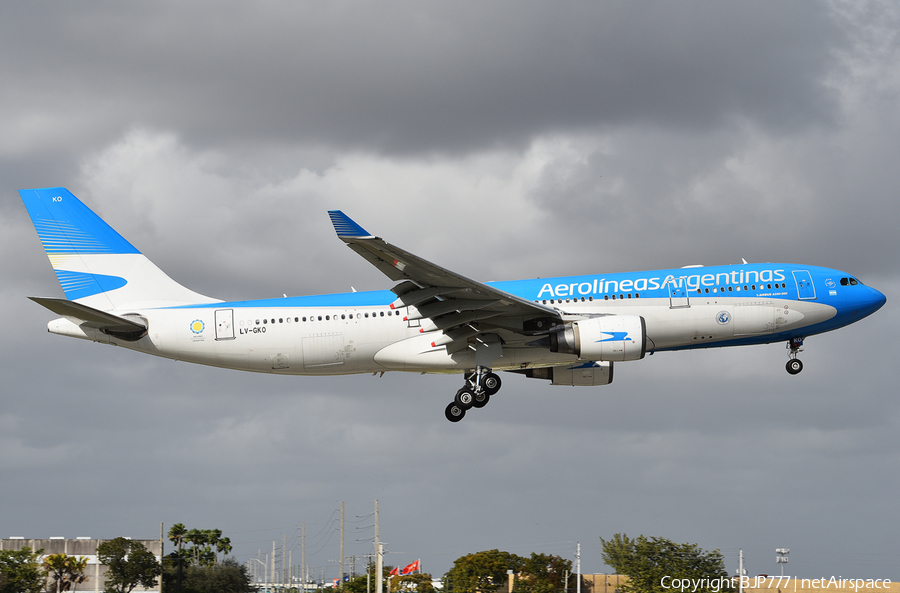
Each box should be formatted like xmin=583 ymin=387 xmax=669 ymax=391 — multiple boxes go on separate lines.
xmin=550 ymin=315 xmax=647 ymax=361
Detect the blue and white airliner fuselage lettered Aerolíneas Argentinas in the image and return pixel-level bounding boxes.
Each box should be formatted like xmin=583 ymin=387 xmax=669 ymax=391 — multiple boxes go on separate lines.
xmin=50 ymin=264 xmax=880 ymax=375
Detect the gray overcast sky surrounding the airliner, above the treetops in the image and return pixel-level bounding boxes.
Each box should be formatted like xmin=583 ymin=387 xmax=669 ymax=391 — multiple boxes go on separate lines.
xmin=0 ymin=1 xmax=900 ymax=580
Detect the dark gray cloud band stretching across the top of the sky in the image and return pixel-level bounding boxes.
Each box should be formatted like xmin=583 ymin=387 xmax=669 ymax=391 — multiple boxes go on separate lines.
xmin=4 ymin=2 xmax=843 ymax=154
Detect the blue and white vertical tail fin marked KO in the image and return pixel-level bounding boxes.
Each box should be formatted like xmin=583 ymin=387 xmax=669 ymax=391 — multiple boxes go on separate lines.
xmin=19 ymin=187 xmax=215 ymax=311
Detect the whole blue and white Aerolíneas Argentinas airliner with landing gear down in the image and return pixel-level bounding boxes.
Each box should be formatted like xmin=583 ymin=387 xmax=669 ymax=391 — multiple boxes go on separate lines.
xmin=19 ymin=188 xmax=886 ymax=422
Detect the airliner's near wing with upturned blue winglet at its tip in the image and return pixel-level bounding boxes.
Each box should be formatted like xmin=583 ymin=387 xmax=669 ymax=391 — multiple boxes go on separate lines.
xmin=328 ymin=210 xmax=562 ymax=343
